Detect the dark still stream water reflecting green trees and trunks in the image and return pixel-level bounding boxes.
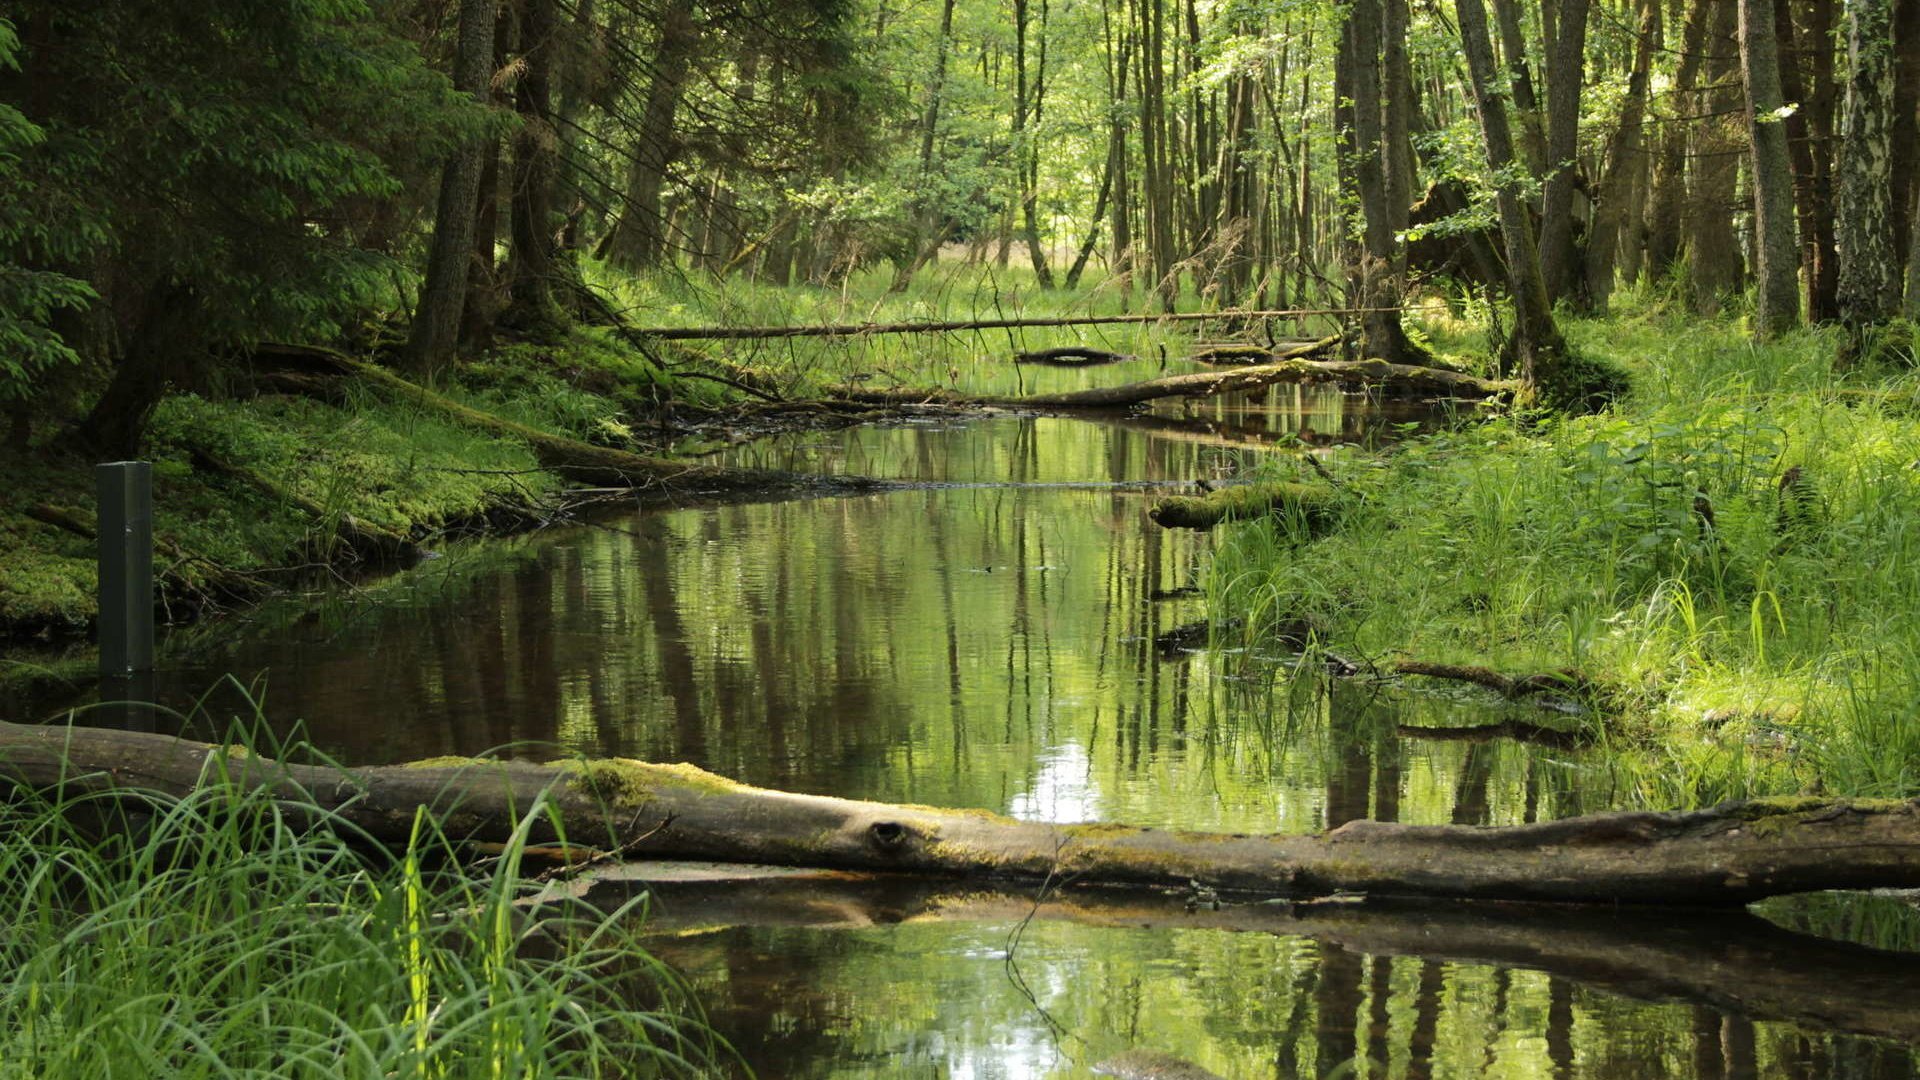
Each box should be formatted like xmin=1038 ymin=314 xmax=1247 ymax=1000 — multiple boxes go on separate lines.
xmin=18 ymin=382 xmax=1920 ymax=1078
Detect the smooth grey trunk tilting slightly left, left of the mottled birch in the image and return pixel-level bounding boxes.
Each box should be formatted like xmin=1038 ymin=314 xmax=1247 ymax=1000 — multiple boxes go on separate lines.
xmin=1740 ymin=0 xmax=1799 ymax=338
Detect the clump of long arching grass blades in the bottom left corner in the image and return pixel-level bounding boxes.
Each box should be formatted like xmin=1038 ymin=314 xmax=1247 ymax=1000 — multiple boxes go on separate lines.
xmin=0 ymin=734 xmax=716 ymax=1078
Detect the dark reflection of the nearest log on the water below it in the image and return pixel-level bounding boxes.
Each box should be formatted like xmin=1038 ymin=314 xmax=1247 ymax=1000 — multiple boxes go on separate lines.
xmin=610 ymin=863 xmax=1920 ymax=1042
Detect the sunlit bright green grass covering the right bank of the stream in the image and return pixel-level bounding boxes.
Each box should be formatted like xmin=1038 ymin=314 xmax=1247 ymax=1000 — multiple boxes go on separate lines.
xmin=1212 ymin=290 xmax=1920 ymax=807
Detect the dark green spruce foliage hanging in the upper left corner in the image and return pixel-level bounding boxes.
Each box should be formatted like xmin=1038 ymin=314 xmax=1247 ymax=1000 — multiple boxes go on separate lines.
xmin=0 ymin=0 xmax=486 ymax=443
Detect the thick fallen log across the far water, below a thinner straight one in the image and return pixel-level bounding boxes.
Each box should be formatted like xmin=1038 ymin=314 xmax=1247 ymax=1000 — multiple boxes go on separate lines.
xmin=835 ymin=338 xmax=1513 ymax=409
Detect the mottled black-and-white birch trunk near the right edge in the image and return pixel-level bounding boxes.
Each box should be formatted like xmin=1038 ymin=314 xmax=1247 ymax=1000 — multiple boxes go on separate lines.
xmin=1837 ymin=0 xmax=1901 ymax=331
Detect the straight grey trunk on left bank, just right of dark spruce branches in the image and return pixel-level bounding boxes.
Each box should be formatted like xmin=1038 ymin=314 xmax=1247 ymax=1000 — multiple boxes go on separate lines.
xmin=407 ymin=0 xmax=497 ymax=379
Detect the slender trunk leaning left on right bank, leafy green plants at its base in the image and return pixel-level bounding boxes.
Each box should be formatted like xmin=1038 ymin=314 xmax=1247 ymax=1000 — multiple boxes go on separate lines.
xmin=1453 ymin=0 xmax=1571 ymax=400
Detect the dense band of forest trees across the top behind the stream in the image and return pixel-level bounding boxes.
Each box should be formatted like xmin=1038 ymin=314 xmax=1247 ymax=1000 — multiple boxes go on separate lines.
xmin=11 ymin=0 xmax=1920 ymax=455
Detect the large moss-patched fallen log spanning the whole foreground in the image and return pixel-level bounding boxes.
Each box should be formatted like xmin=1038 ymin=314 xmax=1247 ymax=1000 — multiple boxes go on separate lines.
xmin=0 ymin=723 xmax=1920 ymax=905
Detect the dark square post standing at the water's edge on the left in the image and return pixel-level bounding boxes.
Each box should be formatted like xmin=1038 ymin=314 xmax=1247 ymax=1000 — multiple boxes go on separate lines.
xmin=94 ymin=461 xmax=154 ymax=678
